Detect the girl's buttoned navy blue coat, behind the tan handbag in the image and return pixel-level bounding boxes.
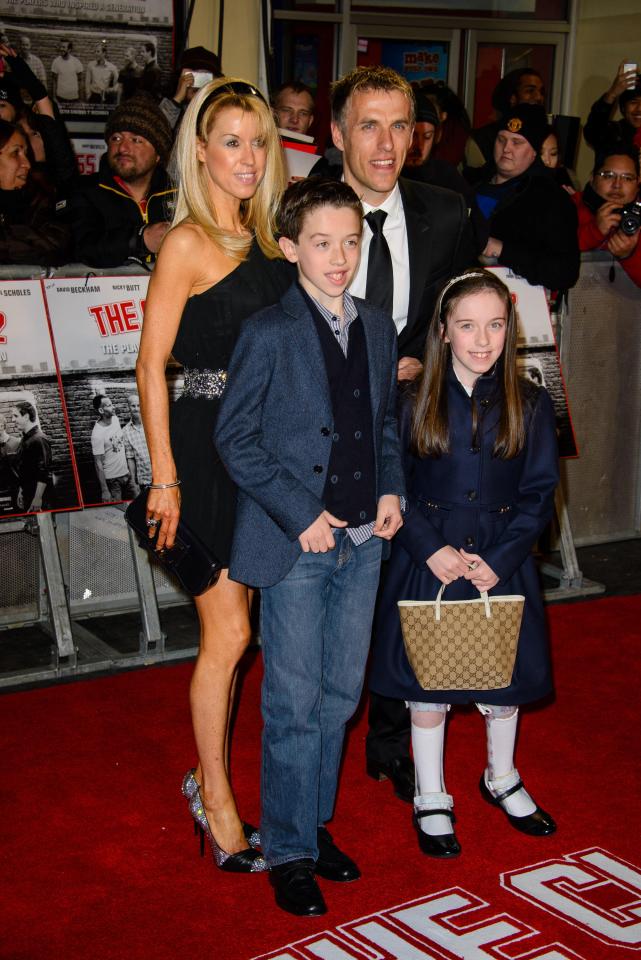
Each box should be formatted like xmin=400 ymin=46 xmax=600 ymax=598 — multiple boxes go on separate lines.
xmin=370 ymin=367 xmax=559 ymax=705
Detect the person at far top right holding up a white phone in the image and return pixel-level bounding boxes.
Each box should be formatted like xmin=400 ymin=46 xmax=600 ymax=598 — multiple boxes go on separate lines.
xmin=583 ymin=62 xmax=641 ymax=154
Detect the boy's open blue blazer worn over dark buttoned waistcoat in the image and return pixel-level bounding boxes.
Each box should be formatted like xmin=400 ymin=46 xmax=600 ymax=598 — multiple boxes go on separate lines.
xmin=214 ymin=284 xmax=405 ymax=587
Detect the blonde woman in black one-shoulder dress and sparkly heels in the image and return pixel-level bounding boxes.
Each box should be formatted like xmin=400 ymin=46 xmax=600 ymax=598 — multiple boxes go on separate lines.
xmin=137 ymin=77 xmax=291 ymax=873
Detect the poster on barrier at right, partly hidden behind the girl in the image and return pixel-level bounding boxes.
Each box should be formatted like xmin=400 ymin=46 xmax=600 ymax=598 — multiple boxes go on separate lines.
xmin=488 ymin=267 xmax=579 ymax=457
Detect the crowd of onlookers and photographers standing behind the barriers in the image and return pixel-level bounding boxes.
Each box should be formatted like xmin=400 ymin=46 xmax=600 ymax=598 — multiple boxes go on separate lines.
xmin=0 ymin=37 xmax=641 ymax=290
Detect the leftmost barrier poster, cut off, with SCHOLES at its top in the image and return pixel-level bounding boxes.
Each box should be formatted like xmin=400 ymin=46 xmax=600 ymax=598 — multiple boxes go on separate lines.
xmin=0 ymin=280 xmax=80 ymax=518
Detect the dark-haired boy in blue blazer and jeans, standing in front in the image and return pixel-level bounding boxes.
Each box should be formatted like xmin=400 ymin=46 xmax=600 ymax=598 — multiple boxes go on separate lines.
xmin=215 ymin=179 xmax=404 ymax=916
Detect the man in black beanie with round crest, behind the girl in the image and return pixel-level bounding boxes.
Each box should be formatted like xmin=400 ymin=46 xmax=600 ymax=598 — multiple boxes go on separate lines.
xmin=476 ymin=103 xmax=580 ymax=290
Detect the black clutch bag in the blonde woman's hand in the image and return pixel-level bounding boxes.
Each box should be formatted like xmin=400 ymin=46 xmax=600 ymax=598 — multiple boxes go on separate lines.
xmin=125 ymin=487 xmax=222 ymax=597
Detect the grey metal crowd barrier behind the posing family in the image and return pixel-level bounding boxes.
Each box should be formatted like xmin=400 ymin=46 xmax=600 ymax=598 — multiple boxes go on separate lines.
xmin=0 ymin=254 xmax=641 ymax=688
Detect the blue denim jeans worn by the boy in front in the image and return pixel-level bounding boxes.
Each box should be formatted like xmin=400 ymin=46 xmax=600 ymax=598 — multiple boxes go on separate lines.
xmin=260 ymin=530 xmax=382 ymax=866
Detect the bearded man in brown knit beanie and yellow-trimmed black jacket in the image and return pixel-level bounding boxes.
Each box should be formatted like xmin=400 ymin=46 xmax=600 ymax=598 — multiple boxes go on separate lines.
xmin=68 ymin=94 xmax=175 ymax=267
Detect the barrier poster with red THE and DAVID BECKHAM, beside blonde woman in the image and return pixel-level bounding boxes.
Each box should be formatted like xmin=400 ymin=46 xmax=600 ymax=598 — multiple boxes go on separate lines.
xmin=44 ymin=276 xmax=151 ymax=506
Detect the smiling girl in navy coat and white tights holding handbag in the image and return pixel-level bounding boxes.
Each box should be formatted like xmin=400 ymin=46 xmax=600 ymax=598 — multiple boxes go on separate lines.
xmin=371 ymin=269 xmax=558 ymax=857
